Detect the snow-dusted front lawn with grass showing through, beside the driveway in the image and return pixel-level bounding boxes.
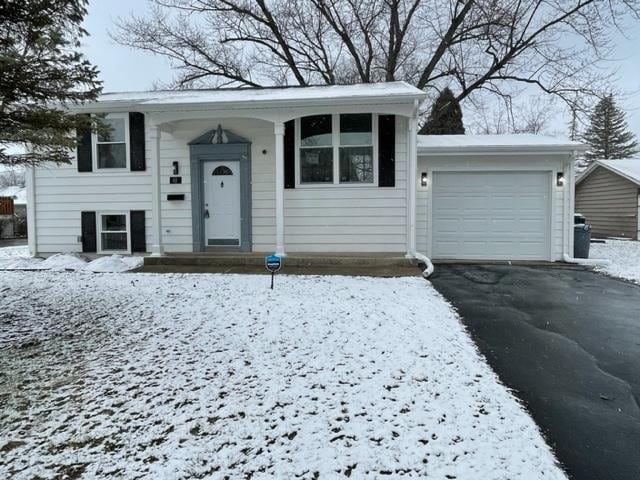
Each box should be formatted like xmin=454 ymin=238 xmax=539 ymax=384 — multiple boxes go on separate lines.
xmin=0 ymin=271 xmax=565 ymax=480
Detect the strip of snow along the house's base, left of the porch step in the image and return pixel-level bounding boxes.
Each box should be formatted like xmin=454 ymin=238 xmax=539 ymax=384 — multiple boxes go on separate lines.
xmin=0 ymin=246 xmax=144 ymax=272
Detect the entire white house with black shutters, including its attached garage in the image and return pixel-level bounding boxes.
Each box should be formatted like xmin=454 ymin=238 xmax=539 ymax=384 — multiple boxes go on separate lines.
xmin=28 ymin=82 xmax=581 ymax=261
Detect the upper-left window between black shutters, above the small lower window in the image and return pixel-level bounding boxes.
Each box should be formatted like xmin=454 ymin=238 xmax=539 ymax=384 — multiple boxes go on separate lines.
xmin=94 ymin=115 xmax=129 ymax=170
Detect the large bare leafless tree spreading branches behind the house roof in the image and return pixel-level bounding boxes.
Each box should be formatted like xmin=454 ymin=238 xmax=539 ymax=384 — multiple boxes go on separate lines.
xmin=113 ymin=0 xmax=640 ymax=117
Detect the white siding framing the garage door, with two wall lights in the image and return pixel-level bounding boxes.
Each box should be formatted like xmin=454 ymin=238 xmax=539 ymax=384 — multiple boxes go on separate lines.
xmin=416 ymin=155 xmax=568 ymax=260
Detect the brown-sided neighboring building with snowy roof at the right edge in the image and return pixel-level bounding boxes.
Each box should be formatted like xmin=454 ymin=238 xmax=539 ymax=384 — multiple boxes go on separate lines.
xmin=576 ymin=159 xmax=640 ymax=240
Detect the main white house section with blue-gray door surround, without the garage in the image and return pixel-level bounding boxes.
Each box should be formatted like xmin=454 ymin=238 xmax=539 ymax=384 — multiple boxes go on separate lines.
xmin=29 ymin=83 xmax=423 ymax=255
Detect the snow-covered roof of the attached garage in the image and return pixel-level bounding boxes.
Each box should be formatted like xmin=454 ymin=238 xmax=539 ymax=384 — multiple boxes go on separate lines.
xmin=418 ymin=134 xmax=584 ymax=153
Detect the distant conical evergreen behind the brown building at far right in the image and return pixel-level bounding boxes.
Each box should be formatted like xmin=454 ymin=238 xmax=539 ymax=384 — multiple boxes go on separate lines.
xmin=583 ymin=93 xmax=638 ymax=162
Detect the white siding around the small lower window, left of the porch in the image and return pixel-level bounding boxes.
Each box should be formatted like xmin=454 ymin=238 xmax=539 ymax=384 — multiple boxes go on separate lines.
xmin=34 ymin=121 xmax=152 ymax=255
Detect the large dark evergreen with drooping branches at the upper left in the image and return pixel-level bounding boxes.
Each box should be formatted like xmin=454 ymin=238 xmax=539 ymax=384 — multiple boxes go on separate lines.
xmin=0 ymin=0 xmax=102 ymax=165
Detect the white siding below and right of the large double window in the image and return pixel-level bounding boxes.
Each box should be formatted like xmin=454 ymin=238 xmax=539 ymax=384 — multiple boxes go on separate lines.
xmin=284 ymin=116 xmax=407 ymax=253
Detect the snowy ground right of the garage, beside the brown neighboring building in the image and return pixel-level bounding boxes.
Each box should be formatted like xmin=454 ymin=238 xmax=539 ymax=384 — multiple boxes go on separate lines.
xmin=589 ymin=240 xmax=640 ymax=283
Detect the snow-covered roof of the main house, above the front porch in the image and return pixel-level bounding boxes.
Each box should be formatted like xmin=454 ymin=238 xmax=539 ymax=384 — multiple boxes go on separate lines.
xmin=90 ymin=82 xmax=426 ymax=109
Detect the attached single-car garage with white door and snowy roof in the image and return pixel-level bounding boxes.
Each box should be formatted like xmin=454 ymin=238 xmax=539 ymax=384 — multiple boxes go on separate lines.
xmin=416 ymin=135 xmax=582 ymax=261
